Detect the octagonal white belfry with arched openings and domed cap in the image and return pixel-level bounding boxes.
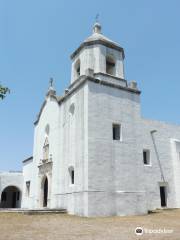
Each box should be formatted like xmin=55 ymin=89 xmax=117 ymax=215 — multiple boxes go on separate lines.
xmin=71 ymin=22 xmax=125 ymax=83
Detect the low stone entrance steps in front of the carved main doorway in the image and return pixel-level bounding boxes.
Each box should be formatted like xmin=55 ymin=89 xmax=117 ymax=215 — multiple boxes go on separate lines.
xmin=0 ymin=208 xmax=67 ymax=215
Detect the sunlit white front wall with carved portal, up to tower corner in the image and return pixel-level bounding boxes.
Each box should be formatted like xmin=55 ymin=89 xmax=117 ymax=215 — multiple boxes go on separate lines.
xmin=23 ymin=83 xmax=87 ymax=215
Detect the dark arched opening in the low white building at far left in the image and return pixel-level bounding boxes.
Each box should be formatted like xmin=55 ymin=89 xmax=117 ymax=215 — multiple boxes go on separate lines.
xmin=0 ymin=186 xmax=21 ymax=208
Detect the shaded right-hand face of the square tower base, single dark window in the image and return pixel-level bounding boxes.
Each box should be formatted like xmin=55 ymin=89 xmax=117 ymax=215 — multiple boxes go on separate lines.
xmin=88 ymin=80 xmax=147 ymax=216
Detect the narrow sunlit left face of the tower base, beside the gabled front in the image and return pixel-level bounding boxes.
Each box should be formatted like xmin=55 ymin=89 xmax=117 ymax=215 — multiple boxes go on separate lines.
xmin=56 ymin=83 xmax=88 ymax=215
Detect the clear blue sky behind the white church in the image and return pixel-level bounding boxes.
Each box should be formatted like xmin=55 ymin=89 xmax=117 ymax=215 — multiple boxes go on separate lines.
xmin=0 ymin=0 xmax=180 ymax=171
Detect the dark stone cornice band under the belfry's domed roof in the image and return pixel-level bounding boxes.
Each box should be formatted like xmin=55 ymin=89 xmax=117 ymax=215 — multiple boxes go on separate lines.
xmin=71 ymin=39 xmax=125 ymax=59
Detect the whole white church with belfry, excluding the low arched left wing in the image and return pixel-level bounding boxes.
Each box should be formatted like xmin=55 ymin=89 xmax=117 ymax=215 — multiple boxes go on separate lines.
xmin=0 ymin=23 xmax=180 ymax=216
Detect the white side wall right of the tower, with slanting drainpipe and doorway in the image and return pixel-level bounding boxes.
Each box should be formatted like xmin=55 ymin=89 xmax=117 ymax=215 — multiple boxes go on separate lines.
xmin=138 ymin=119 xmax=180 ymax=209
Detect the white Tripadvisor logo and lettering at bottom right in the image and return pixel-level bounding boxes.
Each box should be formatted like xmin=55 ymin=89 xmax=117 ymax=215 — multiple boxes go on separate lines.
xmin=135 ymin=227 xmax=174 ymax=236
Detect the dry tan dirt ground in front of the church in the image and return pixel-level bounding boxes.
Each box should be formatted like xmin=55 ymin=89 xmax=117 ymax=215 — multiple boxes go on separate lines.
xmin=0 ymin=210 xmax=180 ymax=240
